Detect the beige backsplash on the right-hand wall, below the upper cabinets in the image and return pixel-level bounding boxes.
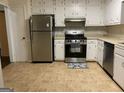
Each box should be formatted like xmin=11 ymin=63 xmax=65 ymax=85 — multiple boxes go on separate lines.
xmin=106 ymin=25 xmax=124 ymax=39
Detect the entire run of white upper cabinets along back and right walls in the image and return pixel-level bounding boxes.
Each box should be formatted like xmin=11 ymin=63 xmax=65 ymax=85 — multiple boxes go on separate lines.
xmin=31 ymin=0 xmax=124 ymax=26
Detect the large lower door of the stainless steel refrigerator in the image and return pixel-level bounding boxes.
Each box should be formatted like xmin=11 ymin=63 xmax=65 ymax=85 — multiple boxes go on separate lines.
xmin=32 ymin=32 xmax=53 ymax=62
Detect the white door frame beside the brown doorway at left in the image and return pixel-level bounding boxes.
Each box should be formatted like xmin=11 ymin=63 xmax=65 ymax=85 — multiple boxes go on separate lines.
xmin=5 ymin=7 xmax=16 ymax=62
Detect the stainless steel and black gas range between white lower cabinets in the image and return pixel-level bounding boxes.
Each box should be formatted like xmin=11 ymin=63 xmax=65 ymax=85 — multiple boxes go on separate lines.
xmin=65 ymin=31 xmax=87 ymax=62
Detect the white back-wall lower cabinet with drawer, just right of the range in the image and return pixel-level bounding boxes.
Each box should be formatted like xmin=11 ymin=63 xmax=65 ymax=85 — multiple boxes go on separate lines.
xmin=86 ymin=40 xmax=97 ymax=61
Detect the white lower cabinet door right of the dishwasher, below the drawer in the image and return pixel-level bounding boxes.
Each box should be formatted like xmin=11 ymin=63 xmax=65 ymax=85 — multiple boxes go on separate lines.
xmin=114 ymin=54 xmax=124 ymax=89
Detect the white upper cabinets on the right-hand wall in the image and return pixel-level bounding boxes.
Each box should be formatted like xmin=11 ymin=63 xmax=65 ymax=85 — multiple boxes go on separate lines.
xmin=105 ymin=0 xmax=124 ymax=25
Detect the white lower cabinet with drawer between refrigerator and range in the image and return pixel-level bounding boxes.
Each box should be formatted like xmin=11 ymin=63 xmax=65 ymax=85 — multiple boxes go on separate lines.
xmin=54 ymin=40 xmax=65 ymax=61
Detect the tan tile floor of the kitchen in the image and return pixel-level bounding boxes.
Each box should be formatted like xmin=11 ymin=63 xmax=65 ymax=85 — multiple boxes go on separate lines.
xmin=3 ymin=62 xmax=122 ymax=92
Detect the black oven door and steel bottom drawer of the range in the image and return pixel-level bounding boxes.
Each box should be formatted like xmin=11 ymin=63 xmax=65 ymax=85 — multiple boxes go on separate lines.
xmin=65 ymin=43 xmax=86 ymax=62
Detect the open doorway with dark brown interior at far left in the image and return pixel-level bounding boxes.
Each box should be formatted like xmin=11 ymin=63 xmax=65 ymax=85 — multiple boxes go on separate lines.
xmin=0 ymin=11 xmax=10 ymax=68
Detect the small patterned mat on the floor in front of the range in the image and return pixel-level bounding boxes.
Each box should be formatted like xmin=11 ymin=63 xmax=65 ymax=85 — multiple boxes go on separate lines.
xmin=67 ymin=63 xmax=88 ymax=69
